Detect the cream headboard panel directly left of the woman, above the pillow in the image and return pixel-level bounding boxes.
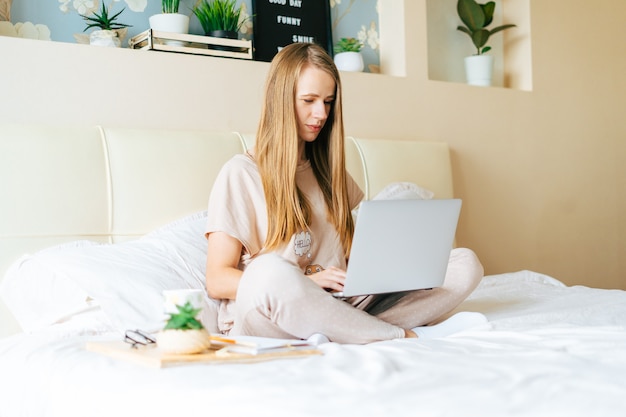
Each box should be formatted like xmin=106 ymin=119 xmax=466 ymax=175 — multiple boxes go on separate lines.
xmin=103 ymin=128 xmax=245 ymax=241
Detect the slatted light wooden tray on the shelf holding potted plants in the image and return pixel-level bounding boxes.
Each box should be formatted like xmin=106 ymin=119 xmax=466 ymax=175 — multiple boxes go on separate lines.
xmin=128 ymin=29 xmax=252 ymax=59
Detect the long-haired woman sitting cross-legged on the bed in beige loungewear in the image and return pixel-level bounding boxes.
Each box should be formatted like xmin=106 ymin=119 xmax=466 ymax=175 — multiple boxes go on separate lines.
xmin=206 ymin=43 xmax=484 ymax=343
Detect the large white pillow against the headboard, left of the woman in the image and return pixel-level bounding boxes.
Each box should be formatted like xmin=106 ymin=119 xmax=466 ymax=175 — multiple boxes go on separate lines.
xmin=3 ymin=212 xmax=219 ymax=332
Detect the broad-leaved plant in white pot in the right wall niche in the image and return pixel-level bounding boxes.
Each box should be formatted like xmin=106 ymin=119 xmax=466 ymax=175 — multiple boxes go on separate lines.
xmin=457 ymin=0 xmax=515 ymax=86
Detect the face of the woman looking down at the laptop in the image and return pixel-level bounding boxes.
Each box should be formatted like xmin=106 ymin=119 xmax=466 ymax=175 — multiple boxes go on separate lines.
xmin=296 ymin=64 xmax=335 ymax=142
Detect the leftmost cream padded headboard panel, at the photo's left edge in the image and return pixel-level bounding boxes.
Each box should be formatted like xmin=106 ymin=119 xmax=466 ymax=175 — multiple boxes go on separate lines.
xmin=0 ymin=126 xmax=109 ymax=237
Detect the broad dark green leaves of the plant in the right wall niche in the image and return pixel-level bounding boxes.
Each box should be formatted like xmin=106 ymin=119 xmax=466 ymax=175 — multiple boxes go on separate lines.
xmin=457 ymin=0 xmax=515 ymax=55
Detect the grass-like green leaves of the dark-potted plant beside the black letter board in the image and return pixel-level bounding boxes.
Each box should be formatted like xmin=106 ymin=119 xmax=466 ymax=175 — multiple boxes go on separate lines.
xmin=192 ymin=0 xmax=248 ymax=35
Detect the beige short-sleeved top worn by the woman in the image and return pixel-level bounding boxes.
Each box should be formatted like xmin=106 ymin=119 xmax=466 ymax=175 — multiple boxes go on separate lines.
xmin=206 ymin=154 xmax=363 ymax=272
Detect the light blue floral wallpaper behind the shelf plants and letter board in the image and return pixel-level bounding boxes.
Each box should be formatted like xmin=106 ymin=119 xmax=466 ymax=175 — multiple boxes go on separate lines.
xmin=0 ymin=0 xmax=380 ymax=72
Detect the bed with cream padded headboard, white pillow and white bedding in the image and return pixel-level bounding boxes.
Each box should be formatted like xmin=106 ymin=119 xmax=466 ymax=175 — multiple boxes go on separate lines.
xmin=0 ymin=125 xmax=626 ymax=417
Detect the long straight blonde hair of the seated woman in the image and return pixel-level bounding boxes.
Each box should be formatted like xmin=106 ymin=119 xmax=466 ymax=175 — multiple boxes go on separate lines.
xmin=255 ymin=43 xmax=354 ymax=256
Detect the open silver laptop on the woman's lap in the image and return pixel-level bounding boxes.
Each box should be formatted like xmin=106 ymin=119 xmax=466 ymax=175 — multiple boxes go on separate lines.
xmin=333 ymin=199 xmax=461 ymax=297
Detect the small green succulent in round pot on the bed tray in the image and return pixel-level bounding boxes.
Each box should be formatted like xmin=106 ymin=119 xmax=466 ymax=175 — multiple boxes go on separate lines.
xmin=157 ymin=302 xmax=211 ymax=354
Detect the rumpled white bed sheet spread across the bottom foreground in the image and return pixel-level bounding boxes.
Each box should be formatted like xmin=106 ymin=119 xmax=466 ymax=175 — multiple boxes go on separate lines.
xmin=0 ymin=271 xmax=626 ymax=417
